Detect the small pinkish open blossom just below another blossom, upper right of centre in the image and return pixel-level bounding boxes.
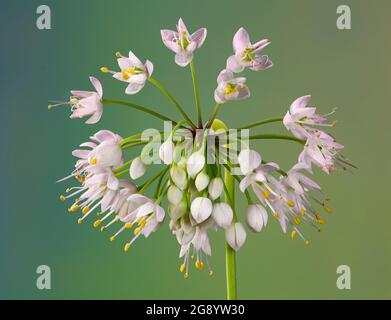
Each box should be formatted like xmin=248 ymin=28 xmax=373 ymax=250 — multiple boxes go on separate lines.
xmin=214 ymin=69 xmax=250 ymax=104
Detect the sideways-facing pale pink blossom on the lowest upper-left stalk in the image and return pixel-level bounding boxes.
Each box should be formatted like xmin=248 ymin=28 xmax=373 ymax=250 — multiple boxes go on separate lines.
xmin=48 ymin=76 xmax=103 ymax=124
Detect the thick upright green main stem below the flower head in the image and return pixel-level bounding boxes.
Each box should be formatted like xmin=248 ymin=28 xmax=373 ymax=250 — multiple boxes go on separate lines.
xmin=224 ymin=169 xmax=237 ymax=300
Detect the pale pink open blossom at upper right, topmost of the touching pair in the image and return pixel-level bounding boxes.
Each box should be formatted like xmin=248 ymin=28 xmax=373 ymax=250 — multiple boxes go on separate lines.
xmin=227 ymin=28 xmax=273 ymax=72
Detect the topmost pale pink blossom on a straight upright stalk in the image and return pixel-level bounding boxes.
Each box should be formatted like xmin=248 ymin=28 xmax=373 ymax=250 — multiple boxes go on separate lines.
xmin=160 ymin=19 xmax=207 ymax=67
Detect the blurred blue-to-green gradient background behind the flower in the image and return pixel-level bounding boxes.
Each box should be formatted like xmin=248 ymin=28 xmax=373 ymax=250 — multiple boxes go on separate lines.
xmin=0 ymin=0 xmax=391 ymax=299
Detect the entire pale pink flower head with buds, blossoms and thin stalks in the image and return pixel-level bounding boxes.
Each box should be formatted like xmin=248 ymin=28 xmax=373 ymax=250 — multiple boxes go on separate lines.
xmin=49 ymin=19 xmax=352 ymax=278
